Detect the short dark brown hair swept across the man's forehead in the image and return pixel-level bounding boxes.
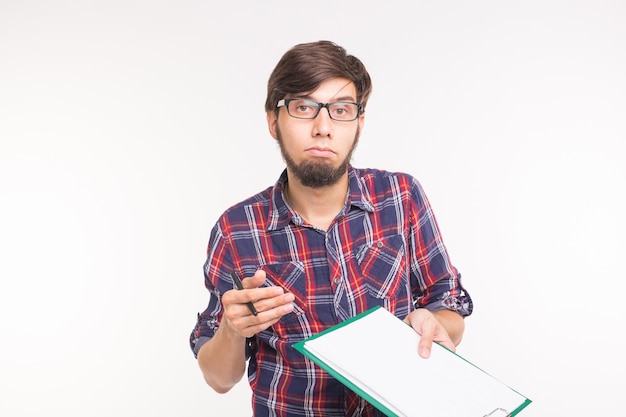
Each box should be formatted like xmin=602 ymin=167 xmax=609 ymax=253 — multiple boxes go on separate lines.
xmin=265 ymin=41 xmax=372 ymax=111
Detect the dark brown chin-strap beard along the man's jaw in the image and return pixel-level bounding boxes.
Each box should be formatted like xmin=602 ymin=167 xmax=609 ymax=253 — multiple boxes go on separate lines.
xmin=276 ymin=126 xmax=360 ymax=188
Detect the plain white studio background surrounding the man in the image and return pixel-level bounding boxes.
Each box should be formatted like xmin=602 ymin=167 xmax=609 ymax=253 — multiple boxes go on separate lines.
xmin=0 ymin=0 xmax=626 ymax=417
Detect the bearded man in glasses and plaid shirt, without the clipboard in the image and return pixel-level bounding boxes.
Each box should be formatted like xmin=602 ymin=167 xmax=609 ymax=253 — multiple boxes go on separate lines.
xmin=190 ymin=41 xmax=472 ymax=417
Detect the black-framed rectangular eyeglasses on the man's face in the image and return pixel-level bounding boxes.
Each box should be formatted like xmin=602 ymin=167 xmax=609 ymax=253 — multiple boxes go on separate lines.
xmin=276 ymin=98 xmax=363 ymax=122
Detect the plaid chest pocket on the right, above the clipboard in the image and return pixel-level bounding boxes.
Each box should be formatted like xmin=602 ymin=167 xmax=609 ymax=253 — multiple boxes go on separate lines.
xmin=355 ymin=235 xmax=408 ymax=299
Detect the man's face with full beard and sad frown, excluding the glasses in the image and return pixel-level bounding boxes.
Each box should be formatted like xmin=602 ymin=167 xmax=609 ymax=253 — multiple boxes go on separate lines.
xmin=267 ymin=78 xmax=364 ymax=188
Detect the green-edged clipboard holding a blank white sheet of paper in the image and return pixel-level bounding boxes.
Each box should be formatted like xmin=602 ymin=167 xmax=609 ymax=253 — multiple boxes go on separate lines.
xmin=293 ymin=307 xmax=532 ymax=417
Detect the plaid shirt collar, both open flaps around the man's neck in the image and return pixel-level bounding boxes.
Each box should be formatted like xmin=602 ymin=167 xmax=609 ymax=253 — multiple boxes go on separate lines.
xmin=267 ymin=165 xmax=374 ymax=230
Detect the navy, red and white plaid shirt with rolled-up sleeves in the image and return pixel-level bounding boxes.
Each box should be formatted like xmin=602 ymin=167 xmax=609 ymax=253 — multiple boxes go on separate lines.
xmin=190 ymin=167 xmax=472 ymax=417
